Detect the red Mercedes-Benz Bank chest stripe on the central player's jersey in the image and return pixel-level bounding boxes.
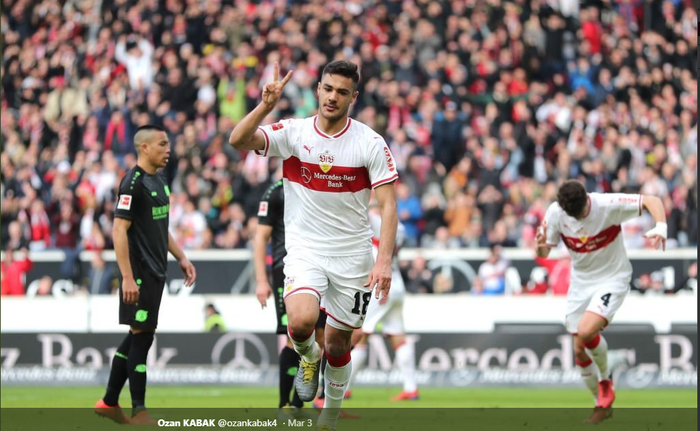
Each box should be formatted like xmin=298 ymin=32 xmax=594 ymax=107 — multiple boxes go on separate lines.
xmin=282 ymin=156 xmax=370 ymax=193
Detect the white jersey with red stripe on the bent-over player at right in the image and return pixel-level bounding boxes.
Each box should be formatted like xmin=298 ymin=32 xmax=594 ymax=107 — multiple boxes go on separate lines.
xmin=545 ymin=193 xmax=642 ymax=288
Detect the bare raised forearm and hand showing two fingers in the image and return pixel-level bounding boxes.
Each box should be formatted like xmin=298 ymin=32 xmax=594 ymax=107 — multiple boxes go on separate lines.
xmin=228 ymin=63 xmax=293 ymax=150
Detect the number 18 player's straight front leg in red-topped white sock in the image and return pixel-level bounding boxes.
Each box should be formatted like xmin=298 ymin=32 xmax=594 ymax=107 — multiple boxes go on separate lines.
xmin=318 ymin=325 xmax=352 ymax=430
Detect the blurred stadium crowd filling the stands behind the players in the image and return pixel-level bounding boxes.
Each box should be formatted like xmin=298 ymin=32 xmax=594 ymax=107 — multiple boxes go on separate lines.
xmin=0 ymin=0 xmax=698 ymax=294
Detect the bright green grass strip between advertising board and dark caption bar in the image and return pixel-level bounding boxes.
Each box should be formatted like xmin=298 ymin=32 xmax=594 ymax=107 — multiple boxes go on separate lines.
xmin=0 ymin=386 xmax=698 ymax=408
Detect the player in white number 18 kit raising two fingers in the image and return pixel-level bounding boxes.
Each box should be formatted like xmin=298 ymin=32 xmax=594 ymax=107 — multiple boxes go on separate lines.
xmin=229 ymin=60 xmax=398 ymax=430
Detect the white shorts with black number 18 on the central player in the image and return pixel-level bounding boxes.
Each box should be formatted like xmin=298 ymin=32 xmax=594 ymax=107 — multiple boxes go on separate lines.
xmin=284 ymin=248 xmax=374 ymax=331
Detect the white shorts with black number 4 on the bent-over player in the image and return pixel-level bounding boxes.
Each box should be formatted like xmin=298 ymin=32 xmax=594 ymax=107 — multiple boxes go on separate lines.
xmin=566 ymin=282 xmax=629 ymax=334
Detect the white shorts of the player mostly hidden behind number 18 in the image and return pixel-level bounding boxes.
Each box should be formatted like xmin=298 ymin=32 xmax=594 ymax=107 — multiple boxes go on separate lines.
xmin=362 ymin=271 xmax=406 ymax=335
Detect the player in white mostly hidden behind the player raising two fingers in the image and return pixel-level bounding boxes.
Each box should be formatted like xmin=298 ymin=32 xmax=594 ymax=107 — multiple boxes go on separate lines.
xmin=345 ymin=209 xmax=419 ymax=401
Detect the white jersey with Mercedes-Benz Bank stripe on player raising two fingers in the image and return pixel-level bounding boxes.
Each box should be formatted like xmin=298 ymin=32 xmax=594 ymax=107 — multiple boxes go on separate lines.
xmin=256 ymin=116 xmax=398 ymax=256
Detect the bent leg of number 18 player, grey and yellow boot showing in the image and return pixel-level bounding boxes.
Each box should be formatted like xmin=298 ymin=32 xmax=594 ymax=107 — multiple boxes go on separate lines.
xmin=284 ymin=293 xmax=321 ymax=402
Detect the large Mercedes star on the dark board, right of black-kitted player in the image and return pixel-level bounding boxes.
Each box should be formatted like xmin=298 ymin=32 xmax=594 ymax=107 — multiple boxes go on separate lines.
xmin=211 ymin=332 xmax=270 ymax=369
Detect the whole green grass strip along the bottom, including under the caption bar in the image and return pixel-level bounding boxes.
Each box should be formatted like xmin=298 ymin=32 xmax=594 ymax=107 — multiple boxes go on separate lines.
xmin=0 ymin=386 xmax=698 ymax=431
